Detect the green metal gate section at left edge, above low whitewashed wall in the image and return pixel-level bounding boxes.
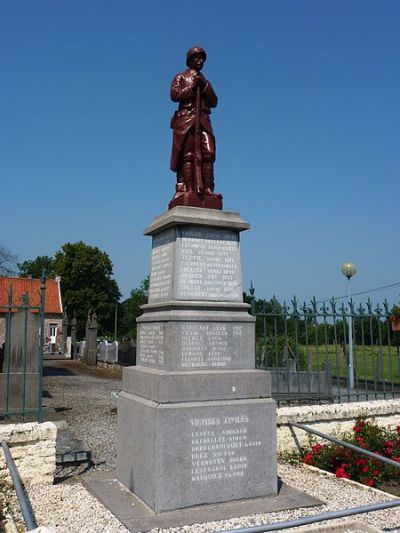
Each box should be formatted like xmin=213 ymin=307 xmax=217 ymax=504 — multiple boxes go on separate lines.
xmin=0 ymin=278 xmax=46 ymax=421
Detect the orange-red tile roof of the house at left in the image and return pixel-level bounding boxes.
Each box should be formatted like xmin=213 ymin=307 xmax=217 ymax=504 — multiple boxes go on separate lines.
xmin=0 ymin=276 xmax=63 ymax=314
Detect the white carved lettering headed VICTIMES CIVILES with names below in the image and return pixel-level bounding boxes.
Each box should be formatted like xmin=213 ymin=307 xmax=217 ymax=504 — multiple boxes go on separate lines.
xmin=190 ymin=414 xmax=262 ymax=483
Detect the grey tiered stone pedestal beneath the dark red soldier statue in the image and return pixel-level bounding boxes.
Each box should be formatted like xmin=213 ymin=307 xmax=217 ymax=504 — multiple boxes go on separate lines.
xmin=117 ymin=206 xmax=277 ymax=513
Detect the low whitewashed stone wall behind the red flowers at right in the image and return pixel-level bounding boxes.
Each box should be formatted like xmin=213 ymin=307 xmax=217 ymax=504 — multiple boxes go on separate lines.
xmin=277 ymin=399 xmax=400 ymax=454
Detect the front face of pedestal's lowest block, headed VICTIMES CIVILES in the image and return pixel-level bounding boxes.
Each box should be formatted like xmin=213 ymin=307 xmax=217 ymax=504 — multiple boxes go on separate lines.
xmin=159 ymin=400 xmax=276 ymax=508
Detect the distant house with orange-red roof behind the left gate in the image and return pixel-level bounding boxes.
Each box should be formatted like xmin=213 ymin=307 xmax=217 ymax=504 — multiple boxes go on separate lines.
xmin=0 ymin=276 xmax=63 ymax=350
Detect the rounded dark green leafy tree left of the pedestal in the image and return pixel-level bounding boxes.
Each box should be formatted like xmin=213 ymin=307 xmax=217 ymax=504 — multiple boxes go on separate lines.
xmin=55 ymin=241 xmax=121 ymax=335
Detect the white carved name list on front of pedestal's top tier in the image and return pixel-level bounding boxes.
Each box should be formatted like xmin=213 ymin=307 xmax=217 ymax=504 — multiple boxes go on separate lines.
xmin=178 ymin=228 xmax=242 ymax=301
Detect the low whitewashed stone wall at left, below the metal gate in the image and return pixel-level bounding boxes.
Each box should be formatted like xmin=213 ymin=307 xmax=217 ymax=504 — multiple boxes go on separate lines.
xmin=0 ymin=422 xmax=57 ymax=485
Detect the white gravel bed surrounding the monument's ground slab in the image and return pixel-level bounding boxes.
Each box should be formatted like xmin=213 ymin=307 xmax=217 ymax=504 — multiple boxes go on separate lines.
xmin=22 ymin=464 xmax=400 ymax=533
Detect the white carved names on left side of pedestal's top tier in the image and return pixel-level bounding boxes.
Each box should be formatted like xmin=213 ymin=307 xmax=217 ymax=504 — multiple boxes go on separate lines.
xmin=149 ymin=230 xmax=175 ymax=301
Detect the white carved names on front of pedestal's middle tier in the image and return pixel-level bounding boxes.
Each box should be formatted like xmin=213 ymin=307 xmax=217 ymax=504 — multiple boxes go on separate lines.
xmin=182 ymin=322 xmax=242 ymax=368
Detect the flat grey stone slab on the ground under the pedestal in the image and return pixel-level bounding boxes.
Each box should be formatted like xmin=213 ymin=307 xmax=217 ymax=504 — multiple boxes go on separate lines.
xmin=82 ymin=472 xmax=322 ymax=533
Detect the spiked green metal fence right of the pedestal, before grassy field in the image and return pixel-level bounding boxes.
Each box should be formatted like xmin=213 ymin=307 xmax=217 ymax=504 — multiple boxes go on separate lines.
xmin=251 ymin=295 xmax=400 ymax=403
